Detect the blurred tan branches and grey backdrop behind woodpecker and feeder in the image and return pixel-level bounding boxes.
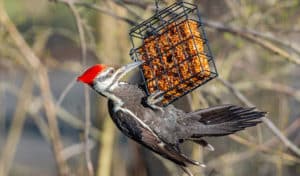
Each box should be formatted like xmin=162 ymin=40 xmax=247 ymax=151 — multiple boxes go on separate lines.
xmin=0 ymin=0 xmax=300 ymax=176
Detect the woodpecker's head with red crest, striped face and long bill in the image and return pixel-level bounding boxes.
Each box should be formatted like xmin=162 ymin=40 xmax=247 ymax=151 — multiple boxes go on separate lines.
xmin=77 ymin=62 xmax=142 ymax=92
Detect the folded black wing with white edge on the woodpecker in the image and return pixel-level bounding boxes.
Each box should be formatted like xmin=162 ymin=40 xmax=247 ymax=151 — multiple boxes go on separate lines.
xmin=108 ymin=100 xmax=201 ymax=167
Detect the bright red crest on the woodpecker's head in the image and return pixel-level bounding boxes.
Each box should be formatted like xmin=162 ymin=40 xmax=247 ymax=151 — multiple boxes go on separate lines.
xmin=77 ymin=64 xmax=106 ymax=84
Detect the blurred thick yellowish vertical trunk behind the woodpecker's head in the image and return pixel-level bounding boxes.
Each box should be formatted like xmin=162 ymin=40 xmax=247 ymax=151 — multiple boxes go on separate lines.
xmin=97 ymin=1 xmax=129 ymax=176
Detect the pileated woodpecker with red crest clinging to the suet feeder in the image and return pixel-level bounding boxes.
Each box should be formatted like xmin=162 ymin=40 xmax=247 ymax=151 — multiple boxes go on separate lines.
xmin=77 ymin=62 xmax=265 ymax=175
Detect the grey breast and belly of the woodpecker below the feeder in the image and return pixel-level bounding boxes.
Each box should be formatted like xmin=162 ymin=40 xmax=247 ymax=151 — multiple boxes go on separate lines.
xmin=109 ymin=84 xmax=182 ymax=143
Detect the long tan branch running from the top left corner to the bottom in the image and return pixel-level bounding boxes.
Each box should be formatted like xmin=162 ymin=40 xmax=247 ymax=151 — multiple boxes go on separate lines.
xmin=0 ymin=0 xmax=69 ymax=175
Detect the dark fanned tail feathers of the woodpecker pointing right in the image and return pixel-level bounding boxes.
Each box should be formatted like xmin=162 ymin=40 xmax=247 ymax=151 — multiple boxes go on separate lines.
xmin=188 ymin=105 xmax=266 ymax=138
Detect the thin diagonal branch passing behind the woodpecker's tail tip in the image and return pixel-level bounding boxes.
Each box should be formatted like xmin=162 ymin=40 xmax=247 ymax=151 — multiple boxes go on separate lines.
xmin=217 ymin=78 xmax=300 ymax=157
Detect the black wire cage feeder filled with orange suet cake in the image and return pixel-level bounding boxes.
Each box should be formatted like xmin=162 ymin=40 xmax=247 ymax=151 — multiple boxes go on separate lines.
xmin=129 ymin=1 xmax=218 ymax=106
